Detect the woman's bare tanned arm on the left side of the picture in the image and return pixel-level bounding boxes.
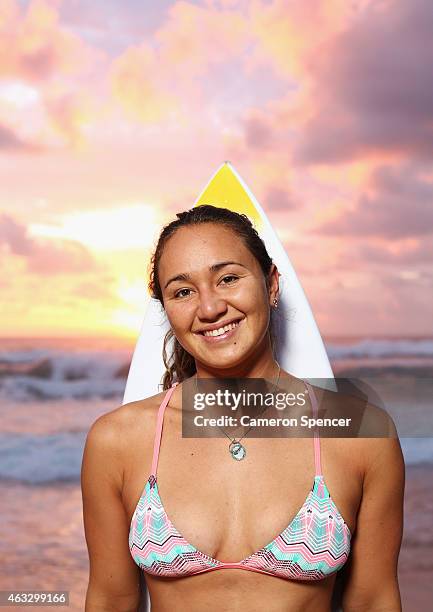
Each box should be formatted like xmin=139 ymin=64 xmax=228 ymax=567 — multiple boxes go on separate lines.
xmin=81 ymin=411 xmax=140 ymax=612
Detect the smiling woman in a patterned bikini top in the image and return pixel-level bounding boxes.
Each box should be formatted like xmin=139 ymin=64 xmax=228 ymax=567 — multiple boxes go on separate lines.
xmin=82 ymin=206 xmax=404 ymax=612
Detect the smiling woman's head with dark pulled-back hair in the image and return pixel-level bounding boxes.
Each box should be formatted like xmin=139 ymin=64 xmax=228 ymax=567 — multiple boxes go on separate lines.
xmin=149 ymin=206 xmax=279 ymax=389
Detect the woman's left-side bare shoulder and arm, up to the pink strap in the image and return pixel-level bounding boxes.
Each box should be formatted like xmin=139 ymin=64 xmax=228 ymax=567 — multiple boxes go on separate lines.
xmin=81 ymin=395 xmax=169 ymax=610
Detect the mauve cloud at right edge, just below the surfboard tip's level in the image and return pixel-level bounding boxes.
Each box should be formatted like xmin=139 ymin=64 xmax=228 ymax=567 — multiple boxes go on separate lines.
xmin=315 ymin=166 xmax=433 ymax=240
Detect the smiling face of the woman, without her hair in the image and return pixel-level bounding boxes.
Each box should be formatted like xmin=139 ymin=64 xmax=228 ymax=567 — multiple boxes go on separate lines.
xmin=159 ymin=223 xmax=278 ymax=370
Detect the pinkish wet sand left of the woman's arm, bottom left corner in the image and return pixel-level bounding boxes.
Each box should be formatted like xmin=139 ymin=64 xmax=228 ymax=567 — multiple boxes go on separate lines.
xmin=0 ymin=482 xmax=88 ymax=612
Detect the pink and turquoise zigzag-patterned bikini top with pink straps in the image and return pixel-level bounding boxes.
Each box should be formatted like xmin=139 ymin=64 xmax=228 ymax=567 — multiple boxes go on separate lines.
xmin=129 ymin=382 xmax=351 ymax=580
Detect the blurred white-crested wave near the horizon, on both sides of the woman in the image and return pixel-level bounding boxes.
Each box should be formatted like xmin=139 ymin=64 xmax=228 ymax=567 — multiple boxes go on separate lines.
xmin=0 ymin=339 xmax=433 ymax=402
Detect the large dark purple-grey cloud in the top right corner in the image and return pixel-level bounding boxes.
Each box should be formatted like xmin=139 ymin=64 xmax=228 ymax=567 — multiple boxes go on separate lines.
xmin=293 ymin=0 xmax=433 ymax=164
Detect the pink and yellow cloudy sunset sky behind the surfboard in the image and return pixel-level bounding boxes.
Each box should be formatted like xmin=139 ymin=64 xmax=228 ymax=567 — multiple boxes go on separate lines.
xmin=0 ymin=0 xmax=433 ymax=338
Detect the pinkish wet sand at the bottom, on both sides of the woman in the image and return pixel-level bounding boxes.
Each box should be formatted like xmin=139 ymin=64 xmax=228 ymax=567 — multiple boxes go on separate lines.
xmin=0 ymin=465 xmax=433 ymax=612
